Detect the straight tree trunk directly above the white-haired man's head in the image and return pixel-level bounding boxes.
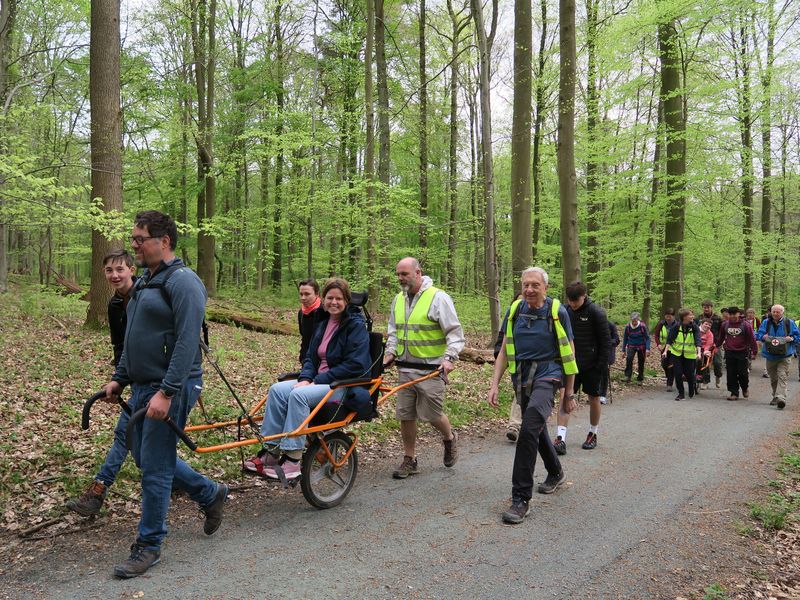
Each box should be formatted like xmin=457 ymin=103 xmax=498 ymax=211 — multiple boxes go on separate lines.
xmin=511 ymin=0 xmax=533 ymax=279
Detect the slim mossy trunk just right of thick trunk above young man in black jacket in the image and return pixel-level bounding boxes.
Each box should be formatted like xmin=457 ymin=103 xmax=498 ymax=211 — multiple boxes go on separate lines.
xmin=586 ymin=0 xmax=600 ymax=284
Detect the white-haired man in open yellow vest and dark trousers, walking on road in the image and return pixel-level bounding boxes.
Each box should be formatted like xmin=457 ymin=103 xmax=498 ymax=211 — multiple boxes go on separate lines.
xmin=487 ymin=267 xmax=578 ymax=524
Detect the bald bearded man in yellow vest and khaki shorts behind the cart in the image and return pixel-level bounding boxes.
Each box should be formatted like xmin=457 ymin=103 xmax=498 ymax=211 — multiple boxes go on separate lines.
xmin=383 ymin=257 xmax=464 ymax=479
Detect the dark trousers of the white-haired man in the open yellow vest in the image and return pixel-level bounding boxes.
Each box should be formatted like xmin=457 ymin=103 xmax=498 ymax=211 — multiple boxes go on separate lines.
xmin=511 ymin=380 xmax=561 ymax=502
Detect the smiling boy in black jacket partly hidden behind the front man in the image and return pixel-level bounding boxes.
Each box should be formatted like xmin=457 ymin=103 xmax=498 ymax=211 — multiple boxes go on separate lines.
xmin=67 ymin=250 xmax=136 ymax=517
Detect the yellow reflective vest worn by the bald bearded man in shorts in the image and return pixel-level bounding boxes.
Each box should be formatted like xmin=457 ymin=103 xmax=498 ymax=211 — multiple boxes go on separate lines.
xmin=394 ymin=287 xmax=447 ymax=358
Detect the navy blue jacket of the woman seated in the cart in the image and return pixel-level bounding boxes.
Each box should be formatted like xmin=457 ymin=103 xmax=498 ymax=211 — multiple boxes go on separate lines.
xmin=298 ymin=306 xmax=371 ymax=415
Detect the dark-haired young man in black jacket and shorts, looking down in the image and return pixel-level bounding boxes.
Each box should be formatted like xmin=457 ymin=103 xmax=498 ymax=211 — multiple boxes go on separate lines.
xmin=553 ymin=281 xmax=611 ymax=455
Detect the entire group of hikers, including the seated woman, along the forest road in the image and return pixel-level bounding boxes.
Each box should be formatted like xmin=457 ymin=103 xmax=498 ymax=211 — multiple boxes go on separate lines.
xmin=67 ymin=211 xmax=800 ymax=579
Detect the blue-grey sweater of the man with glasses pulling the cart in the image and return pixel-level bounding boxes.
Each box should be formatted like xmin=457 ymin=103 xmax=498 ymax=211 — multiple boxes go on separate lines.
xmin=113 ymin=258 xmax=208 ymax=396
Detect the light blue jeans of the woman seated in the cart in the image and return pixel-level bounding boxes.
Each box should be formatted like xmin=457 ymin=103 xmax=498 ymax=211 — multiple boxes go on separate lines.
xmin=261 ymin=379 xmax=345 ymax=452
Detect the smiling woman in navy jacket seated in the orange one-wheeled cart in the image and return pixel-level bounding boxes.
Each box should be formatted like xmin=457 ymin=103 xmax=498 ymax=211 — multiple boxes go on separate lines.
xmin=244 ymin=278 xmax=370 ymax=479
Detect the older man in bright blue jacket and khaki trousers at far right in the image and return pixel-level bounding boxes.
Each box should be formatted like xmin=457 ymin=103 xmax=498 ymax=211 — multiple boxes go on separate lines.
xmin=756 ymin=304 xmax=800 ymax=409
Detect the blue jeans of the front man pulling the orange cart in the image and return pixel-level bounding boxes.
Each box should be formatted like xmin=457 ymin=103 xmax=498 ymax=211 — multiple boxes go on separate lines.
xmin=130 ymin=377 xmax=218 ymax=550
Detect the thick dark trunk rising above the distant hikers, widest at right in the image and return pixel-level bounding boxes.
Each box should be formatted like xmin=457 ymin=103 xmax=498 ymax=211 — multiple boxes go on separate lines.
xmin=658 ymin=19 xmax=686 ymax=307
